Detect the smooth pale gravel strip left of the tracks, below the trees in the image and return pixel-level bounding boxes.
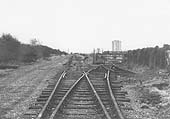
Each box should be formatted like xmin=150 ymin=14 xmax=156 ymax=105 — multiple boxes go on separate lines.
xmin=0 ymin=56 xmax=68 ymax=119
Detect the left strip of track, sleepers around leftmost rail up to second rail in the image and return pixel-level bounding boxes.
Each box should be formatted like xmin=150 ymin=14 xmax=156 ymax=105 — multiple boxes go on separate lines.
xmin=23 ymin=71 xmax=81 ymax=119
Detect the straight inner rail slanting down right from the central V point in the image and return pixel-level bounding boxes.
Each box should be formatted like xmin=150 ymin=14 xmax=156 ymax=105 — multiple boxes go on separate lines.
xmin=85 ymin=73 xmax=111 ymax=119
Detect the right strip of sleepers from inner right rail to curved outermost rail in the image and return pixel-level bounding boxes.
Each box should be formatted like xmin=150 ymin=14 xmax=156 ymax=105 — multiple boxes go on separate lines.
xmin=86 ymin=66 xmax=125 ymax=119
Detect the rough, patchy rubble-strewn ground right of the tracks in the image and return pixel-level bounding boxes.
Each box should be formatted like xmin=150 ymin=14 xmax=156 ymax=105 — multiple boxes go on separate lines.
xmin=121 ymin=65 xmax=170 ymax=119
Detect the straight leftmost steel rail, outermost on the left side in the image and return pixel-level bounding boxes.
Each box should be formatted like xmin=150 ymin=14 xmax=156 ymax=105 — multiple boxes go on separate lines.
xmin=36 ymin=71 xmax=66 ymax=119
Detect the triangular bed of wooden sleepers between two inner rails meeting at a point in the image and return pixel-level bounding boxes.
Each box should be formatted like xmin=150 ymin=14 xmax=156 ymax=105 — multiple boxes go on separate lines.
xmin=50 ymin=74 xmax=108 ymax=119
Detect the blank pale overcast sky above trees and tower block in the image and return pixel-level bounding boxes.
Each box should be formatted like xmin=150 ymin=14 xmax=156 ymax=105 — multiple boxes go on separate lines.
xmin=0 ymin=0 xmax=170 ymax=52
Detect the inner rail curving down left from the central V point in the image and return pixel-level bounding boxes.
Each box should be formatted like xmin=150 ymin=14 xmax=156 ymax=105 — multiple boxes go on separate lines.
xmin=50 ymin=73 xmax=84 ymax=119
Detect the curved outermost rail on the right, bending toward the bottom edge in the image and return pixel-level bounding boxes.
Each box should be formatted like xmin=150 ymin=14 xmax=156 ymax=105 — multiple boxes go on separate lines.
xmin=107 ymin=70 xmax=125 ymax=119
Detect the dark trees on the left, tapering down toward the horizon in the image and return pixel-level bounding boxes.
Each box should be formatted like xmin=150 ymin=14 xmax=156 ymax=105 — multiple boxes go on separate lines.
xmin=0 ymin=34 xmax=66 ymax=63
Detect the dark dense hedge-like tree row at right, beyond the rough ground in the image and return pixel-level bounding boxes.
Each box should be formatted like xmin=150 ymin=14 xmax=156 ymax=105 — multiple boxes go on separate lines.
xmin=126 ymin=44 xmax=170 ymax=69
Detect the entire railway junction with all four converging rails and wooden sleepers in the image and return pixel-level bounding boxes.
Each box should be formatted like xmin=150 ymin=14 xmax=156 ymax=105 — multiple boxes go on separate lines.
xmin=24 ymin=65 xmax=133 ymax=119
